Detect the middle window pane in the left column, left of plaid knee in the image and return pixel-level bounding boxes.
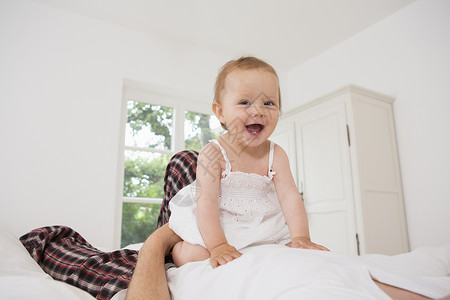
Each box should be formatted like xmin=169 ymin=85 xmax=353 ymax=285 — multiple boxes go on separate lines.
xmin=123 ymin=150 xmax=170 ymax=198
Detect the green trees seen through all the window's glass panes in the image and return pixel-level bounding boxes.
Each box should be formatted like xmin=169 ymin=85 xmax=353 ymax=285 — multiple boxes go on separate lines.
xmin=121 ymin=101 xmax=222 ymax=247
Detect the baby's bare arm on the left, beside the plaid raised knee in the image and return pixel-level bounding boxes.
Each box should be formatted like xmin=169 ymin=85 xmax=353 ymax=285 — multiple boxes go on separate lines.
xmin=196 ymin=143 xmax=241 ymax=268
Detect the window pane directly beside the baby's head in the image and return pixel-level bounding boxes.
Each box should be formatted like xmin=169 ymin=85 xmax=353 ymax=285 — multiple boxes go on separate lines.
xmin=184 ymin=111 xmax=223 ymax=151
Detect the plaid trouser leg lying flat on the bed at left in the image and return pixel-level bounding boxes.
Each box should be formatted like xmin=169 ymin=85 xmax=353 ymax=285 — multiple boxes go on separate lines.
xmin=20 ymin=226 xmax=138 ymax=299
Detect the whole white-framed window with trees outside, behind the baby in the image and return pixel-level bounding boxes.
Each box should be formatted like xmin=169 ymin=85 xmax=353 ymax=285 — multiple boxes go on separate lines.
xmin=116 ymin=85 xmax=222 ymax=247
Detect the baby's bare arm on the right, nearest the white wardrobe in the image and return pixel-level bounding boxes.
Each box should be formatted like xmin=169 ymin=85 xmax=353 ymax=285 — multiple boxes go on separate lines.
xmin=273 ymin=145 xmax=328 ymax=250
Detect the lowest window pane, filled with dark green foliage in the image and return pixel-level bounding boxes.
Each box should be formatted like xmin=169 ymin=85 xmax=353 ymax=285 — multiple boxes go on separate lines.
xmin=120 ymin=203 xmax=161 ymax=247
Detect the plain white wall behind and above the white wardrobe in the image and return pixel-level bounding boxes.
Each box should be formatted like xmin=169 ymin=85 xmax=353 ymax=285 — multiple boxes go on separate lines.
xmin=285 ymin=0 xmax=450 ymax=249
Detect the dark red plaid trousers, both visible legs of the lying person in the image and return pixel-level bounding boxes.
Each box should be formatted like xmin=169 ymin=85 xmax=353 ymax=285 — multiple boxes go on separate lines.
xmin=20 ymin=151 xmax=198 ymax=299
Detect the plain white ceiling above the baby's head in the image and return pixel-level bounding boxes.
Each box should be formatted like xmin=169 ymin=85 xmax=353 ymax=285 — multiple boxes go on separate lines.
xmin=30 ymin=0 xmax=416 ymax=70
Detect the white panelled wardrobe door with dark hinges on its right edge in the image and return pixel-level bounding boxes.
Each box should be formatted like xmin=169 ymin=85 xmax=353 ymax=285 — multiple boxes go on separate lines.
xmin=295 ymin=102 xmax=357 ymax=254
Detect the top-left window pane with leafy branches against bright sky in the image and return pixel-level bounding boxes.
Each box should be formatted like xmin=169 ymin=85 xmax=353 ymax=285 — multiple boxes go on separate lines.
xmin=125 ymin=101 xmax=173 ymax=150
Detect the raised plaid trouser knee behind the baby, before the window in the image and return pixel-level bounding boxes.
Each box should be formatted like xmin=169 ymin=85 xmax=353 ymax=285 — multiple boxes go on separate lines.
xmin=158 ymin=150 xmax=198 ymax=227
